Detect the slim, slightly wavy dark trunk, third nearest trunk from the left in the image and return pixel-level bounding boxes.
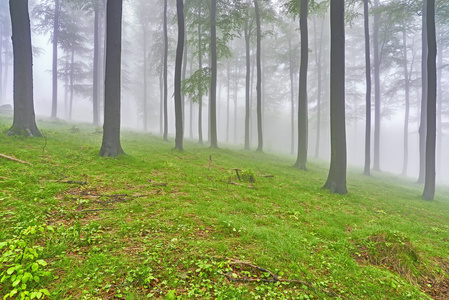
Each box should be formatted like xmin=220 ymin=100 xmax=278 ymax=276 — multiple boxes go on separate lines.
xmin=175 ymin=0 xmax=185 ymax=151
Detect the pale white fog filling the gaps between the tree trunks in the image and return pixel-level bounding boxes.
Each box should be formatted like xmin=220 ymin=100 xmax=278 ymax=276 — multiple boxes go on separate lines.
xmin=0 ymin=0 xmax=449 ymax=184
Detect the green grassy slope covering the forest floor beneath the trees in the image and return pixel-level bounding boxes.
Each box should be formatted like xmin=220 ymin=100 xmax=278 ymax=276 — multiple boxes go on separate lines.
xmin=0 ymin=117 xmax=449 ymax=299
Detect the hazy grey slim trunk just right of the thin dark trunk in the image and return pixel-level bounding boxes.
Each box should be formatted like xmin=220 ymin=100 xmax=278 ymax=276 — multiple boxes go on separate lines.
xmin=373 ymin=0 xmax=381 ymax=171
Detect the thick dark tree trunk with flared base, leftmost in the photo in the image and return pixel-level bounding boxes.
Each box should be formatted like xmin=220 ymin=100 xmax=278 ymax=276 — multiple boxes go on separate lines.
xmin=8 ymin=0 xmax=42 ymax=136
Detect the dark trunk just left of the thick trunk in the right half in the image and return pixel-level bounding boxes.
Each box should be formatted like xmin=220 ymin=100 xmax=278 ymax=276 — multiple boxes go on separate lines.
xmin=295 ymin=0 xmax=309 ymax=171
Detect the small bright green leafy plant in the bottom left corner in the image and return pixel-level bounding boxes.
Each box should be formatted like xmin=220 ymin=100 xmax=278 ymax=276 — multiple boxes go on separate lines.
xmin=0 ymin=225 xmax=53 ymax=300
